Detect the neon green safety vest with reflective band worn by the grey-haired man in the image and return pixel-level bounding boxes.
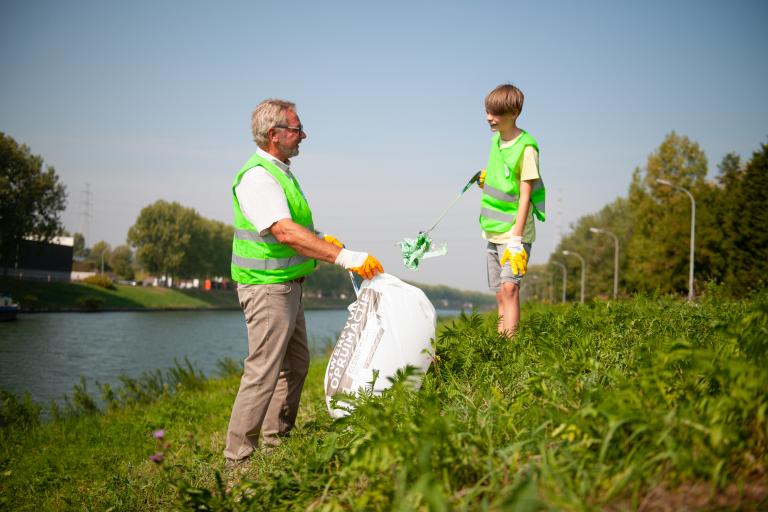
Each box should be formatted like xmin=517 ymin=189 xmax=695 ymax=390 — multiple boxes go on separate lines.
xmin=231 ymin=153 xmax=317 ymax=284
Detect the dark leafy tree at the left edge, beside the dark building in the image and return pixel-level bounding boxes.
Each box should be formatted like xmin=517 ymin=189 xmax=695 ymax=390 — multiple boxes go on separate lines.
xmin=0 ymin=132 xmax=67 ymax=273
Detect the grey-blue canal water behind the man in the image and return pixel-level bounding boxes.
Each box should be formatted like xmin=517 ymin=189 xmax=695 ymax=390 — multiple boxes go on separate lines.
xmin=0 ymin=309 xmax=458 ymax=404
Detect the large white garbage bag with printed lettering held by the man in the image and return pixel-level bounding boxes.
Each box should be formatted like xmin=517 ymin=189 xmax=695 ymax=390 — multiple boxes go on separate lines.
xmin=325 ymin=274 xmax=436 ymax=418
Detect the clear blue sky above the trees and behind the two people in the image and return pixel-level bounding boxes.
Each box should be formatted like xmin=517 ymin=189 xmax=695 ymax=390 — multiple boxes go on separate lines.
xmin=0 ymin=0 xmax=768 ymax=290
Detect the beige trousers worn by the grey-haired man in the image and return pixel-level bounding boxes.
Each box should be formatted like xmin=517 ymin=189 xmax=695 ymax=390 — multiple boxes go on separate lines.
xmin=224 ymin=279 xmax=309 ymax=460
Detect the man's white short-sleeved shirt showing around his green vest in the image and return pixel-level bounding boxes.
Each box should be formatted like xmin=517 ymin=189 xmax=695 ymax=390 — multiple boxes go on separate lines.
xmin=235 ymin=148 xmax=293 ymax=236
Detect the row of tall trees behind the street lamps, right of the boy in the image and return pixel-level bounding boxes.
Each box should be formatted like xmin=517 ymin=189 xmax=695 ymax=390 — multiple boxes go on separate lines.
xmin=532 ymin=132 xmax=768 ymax=298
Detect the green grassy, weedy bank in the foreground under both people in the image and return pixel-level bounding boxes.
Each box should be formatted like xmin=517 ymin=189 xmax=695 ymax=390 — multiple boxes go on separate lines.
xmin=0 ymin=294 xmax=768 ymax=510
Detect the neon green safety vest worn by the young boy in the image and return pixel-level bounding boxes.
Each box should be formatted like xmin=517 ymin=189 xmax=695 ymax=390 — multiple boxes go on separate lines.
xmin=480 ymin=131 xmax=545 ymax=233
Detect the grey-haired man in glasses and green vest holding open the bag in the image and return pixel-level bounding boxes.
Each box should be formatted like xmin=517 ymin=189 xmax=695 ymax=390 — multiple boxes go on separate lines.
xmin=224 ymin=99 xmax=383 ymax=466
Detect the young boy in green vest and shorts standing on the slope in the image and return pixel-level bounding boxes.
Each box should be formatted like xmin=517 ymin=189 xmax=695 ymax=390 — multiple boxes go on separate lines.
xmin=479 ymin=84 xmax=544 ymax=336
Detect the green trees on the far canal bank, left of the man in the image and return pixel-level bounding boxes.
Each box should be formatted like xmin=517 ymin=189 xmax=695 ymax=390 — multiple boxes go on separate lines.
xmin=0 ymin=132 xmax=233 ymax=279
